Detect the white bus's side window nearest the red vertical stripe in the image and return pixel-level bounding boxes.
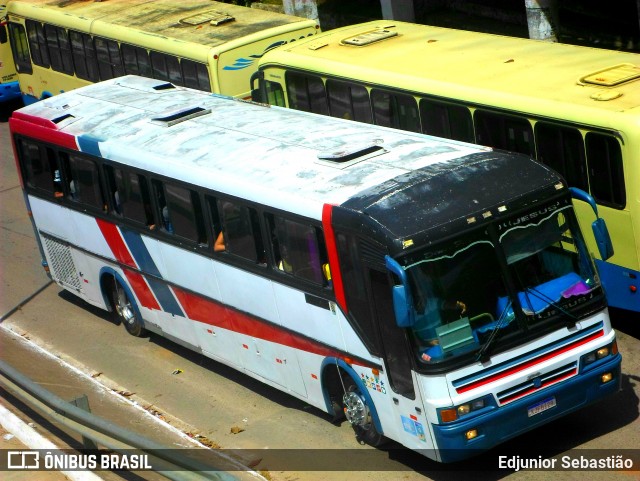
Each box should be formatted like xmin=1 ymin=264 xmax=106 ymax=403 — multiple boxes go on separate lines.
xmin=266 ymin=214 xmax=327 ymax=285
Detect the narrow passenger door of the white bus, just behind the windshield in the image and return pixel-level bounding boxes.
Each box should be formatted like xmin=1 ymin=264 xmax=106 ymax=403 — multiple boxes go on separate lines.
xmin=368 ymin=268 xmax=434 ymax=449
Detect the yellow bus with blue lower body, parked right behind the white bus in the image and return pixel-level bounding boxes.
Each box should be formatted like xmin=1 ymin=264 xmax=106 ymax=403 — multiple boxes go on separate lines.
xmin=251 ymin=20 xmax=640 ymax=311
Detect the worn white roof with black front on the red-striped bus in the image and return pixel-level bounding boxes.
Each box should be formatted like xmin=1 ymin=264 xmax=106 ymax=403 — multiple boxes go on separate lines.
xmin=12 ymin=76 xmax=566 ymax=248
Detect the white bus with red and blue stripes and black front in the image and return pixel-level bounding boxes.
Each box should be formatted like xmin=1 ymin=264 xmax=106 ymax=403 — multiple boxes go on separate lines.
xmin=10 ymin=76 xmax=621 ymax=462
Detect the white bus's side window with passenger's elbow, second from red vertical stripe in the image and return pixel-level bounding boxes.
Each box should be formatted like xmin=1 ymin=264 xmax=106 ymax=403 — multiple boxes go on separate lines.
xmin=218 ymin=200 xmax=266 ymax=264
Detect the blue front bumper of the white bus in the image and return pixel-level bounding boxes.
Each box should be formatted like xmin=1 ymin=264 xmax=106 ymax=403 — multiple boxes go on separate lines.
xmin=432 ymin=354 xmax=622 ymax=463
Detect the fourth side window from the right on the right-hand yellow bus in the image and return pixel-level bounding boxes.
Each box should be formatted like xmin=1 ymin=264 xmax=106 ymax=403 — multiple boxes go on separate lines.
xmin=420 ymin=99 xmax=475 ymax=143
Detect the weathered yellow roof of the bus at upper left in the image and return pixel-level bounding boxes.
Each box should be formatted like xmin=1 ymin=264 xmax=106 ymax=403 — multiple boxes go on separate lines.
xmin=8 ymin=0 xmax=312 ymax=48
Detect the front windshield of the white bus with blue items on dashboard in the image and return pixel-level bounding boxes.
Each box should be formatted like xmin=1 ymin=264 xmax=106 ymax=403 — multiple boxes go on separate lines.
xmin=404 ymin=206 xmax=600 ymax=366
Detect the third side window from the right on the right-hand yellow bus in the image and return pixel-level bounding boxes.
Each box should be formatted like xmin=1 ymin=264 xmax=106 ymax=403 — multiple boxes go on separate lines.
xmin=474 ymin=110 xmax=536 ymax=158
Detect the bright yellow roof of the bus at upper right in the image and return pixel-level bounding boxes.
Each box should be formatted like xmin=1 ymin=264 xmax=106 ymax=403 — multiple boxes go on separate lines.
xmin=261 ymin=20 xmax=640 ymax=116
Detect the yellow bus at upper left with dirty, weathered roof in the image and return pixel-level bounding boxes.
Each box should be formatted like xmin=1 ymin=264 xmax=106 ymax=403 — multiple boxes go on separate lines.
xmin=7 ymin=0 xmax=319 ymax=104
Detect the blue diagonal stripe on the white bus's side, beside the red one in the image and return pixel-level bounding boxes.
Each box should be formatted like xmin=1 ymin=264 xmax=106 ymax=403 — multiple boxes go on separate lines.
xmin=120 ymin=228 xmax=186 ymax=317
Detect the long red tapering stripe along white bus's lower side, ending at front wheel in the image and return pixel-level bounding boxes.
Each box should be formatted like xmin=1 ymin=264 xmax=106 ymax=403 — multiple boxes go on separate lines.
xmin=173 ymin=287 xmax=365 ymax=365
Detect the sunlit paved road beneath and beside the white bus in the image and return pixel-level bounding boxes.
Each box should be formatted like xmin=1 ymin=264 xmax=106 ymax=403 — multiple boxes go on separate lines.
xmin=0 ymin=98 xmax=640 ymax=481
